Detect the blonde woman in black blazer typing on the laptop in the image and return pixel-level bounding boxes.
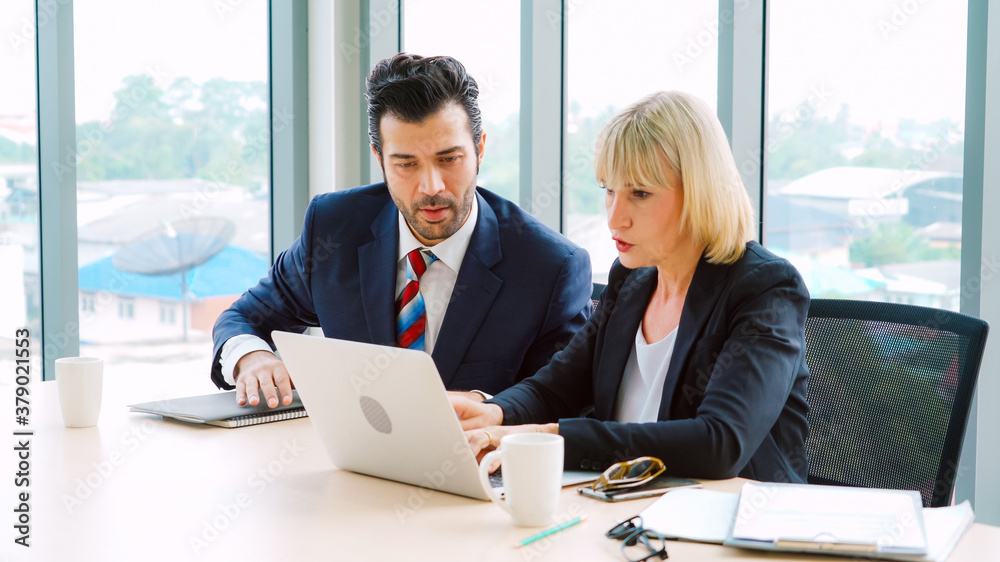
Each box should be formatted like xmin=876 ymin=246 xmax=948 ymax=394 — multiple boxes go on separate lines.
xmin=452 ymin=92 xmax=809 ymax=482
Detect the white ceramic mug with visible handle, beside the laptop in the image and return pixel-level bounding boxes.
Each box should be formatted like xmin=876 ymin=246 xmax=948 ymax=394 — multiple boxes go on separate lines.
xmin=479 ymin=433 xmax=563 ymax=527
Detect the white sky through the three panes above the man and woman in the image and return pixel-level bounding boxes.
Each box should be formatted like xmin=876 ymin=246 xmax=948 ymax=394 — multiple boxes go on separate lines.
xmin=404 ymin=0 xmax=968 ymax=126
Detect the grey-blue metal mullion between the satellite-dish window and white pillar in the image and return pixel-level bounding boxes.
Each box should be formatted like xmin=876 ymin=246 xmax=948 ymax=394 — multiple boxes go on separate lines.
xmin=268 ymin=0 xmax=309 ymax=262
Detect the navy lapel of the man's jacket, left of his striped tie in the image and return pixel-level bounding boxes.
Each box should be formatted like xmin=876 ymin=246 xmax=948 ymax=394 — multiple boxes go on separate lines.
xmin=358 ymin=201 xmax=399 ymax=345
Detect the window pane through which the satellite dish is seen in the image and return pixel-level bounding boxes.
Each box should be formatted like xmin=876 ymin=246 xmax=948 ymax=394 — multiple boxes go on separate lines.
xmin=74 ymin=0 xmax=270 ymax=368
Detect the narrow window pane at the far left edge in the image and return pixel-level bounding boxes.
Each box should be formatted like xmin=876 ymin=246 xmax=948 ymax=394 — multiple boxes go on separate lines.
xmin=0 ymin=0 xmax=42 ymax=384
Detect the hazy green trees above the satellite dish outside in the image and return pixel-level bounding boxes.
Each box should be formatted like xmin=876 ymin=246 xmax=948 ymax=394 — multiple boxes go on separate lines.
xmin=77 ymin=75 xmax=270 ymax=189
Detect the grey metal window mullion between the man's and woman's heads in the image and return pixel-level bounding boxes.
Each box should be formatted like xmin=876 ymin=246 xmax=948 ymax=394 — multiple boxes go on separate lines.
xmin=518 ymin=0 xmax=565 ymax=231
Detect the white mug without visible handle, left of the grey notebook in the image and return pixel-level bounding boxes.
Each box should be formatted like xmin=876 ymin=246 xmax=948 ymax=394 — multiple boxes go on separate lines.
xmin=56 ymin=357 xmax=104 ymax=427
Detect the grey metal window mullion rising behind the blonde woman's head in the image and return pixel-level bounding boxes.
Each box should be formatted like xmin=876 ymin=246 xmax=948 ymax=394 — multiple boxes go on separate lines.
xmin=718 ymin=0 xmax=767 ymax=241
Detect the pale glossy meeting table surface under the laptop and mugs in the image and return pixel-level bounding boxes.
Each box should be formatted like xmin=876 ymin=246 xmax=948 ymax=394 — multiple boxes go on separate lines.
xmin=0 ymin=368 xmax=1000 ymax=562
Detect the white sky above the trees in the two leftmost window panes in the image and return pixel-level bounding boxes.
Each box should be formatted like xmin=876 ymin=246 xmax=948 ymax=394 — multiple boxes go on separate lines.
xmin=0 ymin=0 xmax=268 ymax=123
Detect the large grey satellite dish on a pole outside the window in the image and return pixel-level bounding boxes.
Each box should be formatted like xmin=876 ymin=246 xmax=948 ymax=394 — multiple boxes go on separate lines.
xmin=111 ymin=217 xmax=236 ymax=341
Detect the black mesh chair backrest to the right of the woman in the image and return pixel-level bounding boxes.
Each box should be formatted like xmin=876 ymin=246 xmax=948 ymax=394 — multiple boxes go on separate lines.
xmin=806 ymin=299 xmax=989 ymax=507
